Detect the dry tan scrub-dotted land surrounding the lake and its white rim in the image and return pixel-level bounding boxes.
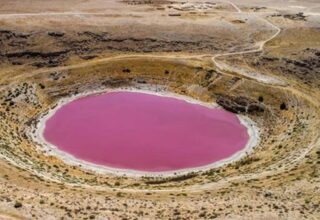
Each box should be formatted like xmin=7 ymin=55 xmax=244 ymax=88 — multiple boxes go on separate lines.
xmin=0 ymin=0 xmax=320 ymax=219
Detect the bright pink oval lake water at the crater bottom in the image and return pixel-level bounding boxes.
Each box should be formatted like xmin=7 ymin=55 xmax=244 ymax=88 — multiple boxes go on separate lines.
xmin=44 ymin=92 xmax=249 ymax=172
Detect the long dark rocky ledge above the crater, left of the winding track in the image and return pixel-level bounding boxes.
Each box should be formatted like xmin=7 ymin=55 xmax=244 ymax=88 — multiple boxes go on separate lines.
xmin=0 ymin=28 xmax=220 ymax=68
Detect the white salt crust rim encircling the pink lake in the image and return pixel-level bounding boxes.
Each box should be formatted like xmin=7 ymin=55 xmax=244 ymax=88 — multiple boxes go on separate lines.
xmin=31 ymin=86 xmax=260 ymax=177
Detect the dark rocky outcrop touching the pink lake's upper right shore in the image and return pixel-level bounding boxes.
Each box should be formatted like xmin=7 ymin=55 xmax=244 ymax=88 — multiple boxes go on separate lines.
xmin=216 ymin=95 xmax=264 ymax=113
